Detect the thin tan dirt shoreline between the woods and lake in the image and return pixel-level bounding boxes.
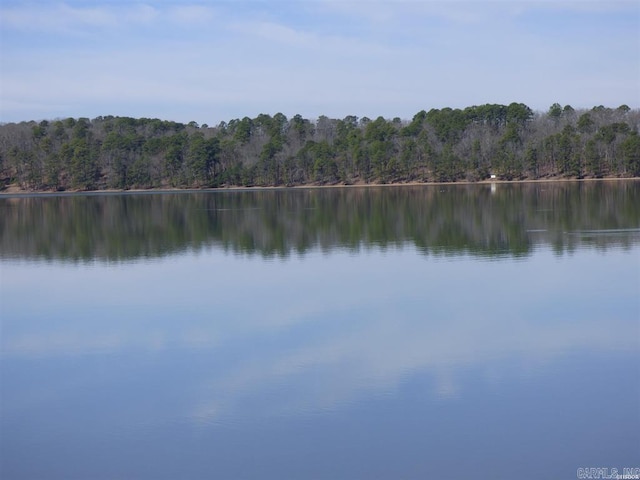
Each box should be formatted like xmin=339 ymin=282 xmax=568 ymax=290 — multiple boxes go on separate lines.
xmin=0 ymin=177 xmax=640 ymax=198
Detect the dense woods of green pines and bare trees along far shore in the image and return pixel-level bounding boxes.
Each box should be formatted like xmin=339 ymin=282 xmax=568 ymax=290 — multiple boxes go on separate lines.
xmin=0 ymin=103 xmax=640 ymax=191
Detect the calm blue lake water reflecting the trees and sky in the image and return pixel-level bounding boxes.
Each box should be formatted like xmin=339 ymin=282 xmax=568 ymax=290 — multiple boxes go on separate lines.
xmin=0 ymin=182 xmax=640 ymax=479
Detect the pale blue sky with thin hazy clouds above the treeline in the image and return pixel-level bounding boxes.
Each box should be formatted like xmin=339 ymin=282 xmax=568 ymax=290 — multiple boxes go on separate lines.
xmin=0 ymin=0 xmax=640 ymax=126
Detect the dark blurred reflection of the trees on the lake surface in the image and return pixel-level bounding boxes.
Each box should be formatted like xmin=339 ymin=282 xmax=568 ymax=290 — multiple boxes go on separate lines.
xmin=0 ymin=181 xmax=640 ymax=260
